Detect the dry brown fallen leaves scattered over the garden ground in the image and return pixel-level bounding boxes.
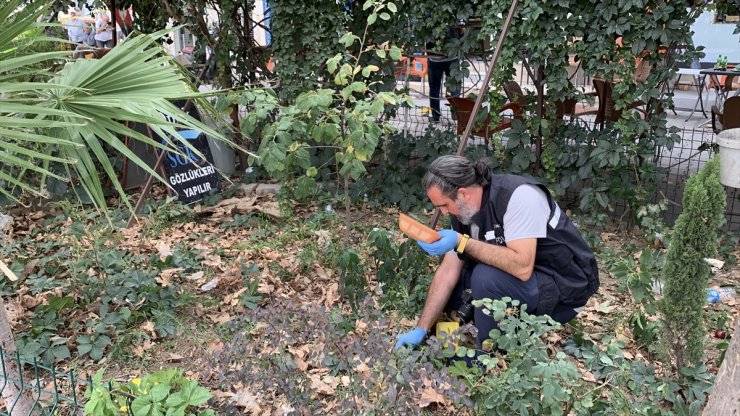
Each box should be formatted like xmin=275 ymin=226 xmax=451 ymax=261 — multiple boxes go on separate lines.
xmin=0 ymin=195 xmax=740 ymax=414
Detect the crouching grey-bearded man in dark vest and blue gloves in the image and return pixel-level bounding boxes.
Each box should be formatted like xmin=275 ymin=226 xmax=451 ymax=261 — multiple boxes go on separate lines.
xmin=395 ymin=156 xmax=599 ymax=349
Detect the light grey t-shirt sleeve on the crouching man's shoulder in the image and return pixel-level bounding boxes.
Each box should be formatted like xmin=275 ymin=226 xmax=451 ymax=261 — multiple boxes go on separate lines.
xmin=503 ymin=184 xmax=550 ymax=243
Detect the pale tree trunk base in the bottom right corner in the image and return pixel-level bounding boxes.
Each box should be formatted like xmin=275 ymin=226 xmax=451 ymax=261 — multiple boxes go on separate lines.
xmin=702 ymin=319 xmax=740 ymax=416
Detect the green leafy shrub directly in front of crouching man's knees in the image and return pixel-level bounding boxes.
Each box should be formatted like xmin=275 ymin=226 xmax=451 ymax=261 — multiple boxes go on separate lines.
xmin=450 ymin=297 xmax=591 ymax=415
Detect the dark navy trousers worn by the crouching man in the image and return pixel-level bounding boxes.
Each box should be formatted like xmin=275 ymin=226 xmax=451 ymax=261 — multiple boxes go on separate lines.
xmin=447 ymin=264 xmax=578 ymax=348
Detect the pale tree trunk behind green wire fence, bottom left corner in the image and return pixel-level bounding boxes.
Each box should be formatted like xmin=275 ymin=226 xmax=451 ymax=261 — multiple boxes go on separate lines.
xmin=0 ymin=297 xmax=34 ymax=416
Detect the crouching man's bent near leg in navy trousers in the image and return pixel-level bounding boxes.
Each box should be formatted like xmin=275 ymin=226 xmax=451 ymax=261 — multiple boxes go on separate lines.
xmin=470 ymin=264 xmax=539 ymax=348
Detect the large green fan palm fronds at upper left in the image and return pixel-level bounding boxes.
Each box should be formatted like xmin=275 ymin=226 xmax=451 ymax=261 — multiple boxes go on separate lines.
xmin=0 ymin=0 xmax=247 ymax=219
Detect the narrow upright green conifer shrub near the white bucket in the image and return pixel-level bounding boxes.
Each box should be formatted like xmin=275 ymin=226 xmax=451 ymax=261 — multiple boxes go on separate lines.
xmin=659 ymin=157 xmax=727 ymax=370
